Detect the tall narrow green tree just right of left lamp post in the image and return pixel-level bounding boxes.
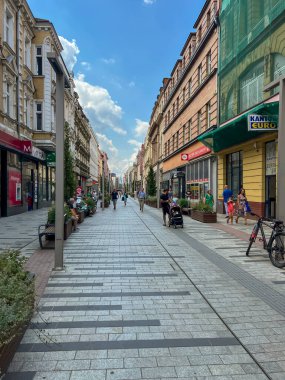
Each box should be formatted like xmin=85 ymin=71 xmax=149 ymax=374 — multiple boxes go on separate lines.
xmin=64 ymin=122 xmax=76 ymax=201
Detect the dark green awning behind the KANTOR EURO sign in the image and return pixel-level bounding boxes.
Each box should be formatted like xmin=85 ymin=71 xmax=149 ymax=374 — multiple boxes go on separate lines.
xmin=198 ymin=102 xmax=279 ymax=152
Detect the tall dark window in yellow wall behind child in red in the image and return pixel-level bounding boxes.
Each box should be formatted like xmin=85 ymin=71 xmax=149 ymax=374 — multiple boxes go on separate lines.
xmin=226 ymin=151 xmax=243 ymax=197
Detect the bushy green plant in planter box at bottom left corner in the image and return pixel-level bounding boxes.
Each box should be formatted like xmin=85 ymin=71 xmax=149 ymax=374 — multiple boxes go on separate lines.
xmin=0 ymin=250 xmax=35 ymax=377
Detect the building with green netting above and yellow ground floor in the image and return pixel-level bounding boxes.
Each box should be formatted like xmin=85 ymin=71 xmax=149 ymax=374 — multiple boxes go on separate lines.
xmin=202 ymin=0 xmax=285 ymax=217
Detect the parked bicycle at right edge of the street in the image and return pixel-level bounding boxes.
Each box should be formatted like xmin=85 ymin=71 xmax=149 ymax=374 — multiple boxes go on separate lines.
xmin=246 ymin=212 xmax=285 ymax=268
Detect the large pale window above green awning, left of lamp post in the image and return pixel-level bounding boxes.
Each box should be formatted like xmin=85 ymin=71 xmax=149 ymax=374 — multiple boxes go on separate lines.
xmin=239 ymin=61 xmax=264 ymax=112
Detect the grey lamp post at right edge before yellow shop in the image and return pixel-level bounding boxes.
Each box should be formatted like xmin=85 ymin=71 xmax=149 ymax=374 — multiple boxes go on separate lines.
xmin=264 ymin=76 xmax=285 ymax=221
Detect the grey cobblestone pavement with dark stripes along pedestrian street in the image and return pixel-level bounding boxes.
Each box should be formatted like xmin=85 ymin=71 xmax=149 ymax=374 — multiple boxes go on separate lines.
xmin=5 ymin=200 xmax=285 ymax=380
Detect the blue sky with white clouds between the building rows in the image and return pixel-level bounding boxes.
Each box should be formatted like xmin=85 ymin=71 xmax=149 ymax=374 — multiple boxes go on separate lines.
xmin=28 ymin=0 xmax=205 ymax=174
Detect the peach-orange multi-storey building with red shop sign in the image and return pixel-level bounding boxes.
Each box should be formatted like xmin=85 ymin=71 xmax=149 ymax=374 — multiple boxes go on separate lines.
xmin=162 ymin=0 xmax=219 ymax=201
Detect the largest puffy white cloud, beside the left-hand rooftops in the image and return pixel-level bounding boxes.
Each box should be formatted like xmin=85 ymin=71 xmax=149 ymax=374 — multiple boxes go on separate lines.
xmin=74 ymin=74 xmax=127 ymax=135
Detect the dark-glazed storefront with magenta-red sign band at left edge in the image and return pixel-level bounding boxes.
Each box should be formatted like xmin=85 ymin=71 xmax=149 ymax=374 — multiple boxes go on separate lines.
xmin=0 ymin=131 xmax=53 ymax=217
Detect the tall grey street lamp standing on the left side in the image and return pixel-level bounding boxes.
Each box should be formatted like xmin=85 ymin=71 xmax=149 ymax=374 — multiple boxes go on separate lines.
xmin=47 ymin=52 xmax=70 ymax=270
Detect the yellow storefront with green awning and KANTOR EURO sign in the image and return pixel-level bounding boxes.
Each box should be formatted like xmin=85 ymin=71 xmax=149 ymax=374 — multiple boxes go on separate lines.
xmin=197 ymin=100 xmax=279 ymax=217
